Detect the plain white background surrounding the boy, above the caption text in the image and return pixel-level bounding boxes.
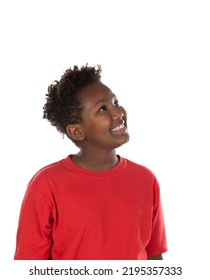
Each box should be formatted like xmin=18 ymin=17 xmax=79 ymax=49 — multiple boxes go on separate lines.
xmin=0 ymin=0 xmax=210 ymax=278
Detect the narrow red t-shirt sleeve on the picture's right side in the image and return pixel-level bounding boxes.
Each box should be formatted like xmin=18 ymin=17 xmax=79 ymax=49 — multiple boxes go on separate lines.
xmin=146 ymin=177 xmax=167 ymax=256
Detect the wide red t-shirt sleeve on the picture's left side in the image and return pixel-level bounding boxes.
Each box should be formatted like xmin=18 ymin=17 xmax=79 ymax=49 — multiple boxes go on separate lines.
xmin=14 ymin=174 xmax=54 ymax=260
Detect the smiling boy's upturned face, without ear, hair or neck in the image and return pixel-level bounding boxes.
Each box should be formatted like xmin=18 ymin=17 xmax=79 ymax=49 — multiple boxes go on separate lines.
xmin=80 ymin=83 xmax=129 ymax=150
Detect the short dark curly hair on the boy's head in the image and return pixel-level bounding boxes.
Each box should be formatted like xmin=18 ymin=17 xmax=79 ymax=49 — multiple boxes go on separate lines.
xmin=43 ymin=64 xmax=101 ymax=142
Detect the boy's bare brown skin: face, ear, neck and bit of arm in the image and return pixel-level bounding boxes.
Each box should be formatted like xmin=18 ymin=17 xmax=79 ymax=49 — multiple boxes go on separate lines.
xmin=66 ymin=83 xmax=163 ymax=260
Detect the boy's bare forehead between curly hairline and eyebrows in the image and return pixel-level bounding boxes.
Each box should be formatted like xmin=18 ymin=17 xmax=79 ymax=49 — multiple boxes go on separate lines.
xmin=80 ymin=83 xmax=115 ymax=106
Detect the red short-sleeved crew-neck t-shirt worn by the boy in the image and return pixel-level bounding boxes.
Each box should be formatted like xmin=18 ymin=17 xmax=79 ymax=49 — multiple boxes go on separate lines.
xmin=14 ymin=156 xmax=167 ymax=260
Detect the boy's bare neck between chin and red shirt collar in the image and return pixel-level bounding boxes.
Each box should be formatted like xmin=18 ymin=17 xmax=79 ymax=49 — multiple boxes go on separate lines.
xmin=72 ymin=150 xmax=118 ymax=172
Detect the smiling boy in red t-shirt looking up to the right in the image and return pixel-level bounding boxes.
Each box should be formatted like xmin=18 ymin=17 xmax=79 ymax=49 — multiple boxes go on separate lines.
xmin=15 ymin=65 xmax=167 ymax=260
